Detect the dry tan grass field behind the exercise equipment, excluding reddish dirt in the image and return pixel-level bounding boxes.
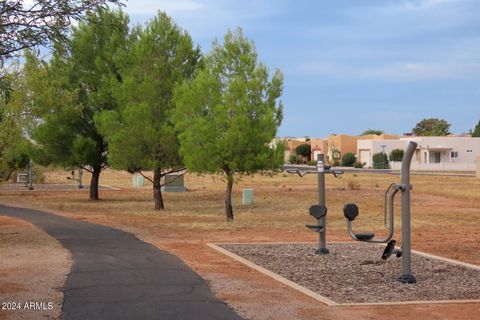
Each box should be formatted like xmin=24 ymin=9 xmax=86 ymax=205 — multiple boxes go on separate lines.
xmin=2 ymin=170 xmax=480 ymax=262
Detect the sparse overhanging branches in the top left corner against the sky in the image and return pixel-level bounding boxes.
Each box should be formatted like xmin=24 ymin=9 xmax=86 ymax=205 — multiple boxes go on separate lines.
xmin=0 ymin=0 xmax=121 ymax=65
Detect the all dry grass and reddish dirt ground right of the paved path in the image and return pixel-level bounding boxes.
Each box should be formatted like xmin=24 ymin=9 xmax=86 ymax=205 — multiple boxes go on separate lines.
xmin=0 ymin=171 xmax=480 ymax=320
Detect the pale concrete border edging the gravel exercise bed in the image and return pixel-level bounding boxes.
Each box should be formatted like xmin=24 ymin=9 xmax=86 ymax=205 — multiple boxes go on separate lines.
xmin=206 ymin=242 xmax=480 ymax=307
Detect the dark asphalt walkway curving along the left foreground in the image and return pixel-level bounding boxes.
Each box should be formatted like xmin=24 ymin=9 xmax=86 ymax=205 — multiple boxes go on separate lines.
xmin=0 ymin=205 xmax=241 ymax=320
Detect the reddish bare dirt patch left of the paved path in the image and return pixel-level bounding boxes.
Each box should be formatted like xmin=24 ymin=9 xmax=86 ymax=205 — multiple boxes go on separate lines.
xmin=0 ymin=213 xmax=71 ymax=320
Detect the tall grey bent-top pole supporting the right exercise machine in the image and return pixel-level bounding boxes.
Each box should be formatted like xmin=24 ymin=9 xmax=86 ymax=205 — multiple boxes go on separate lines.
xmin=398 ymin=141 xmax=418 ymax=283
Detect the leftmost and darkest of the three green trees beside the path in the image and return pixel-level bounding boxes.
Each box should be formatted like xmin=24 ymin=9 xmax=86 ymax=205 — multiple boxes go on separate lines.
xmin=25 ymin=9 xmax=129 ymax=200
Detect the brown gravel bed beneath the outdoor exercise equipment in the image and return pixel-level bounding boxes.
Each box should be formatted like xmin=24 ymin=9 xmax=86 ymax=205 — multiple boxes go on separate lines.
xmin=220 ymin=243 xmax=480 ymax=303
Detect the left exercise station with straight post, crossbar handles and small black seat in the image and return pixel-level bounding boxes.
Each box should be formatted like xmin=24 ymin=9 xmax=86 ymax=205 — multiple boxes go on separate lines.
xmin=287 ymin=154 xmax=343 ymax=254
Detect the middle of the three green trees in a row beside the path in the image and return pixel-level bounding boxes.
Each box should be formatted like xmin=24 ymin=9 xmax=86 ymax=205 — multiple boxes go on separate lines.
xmin=95 ymin=13 xmax=200 ymax=210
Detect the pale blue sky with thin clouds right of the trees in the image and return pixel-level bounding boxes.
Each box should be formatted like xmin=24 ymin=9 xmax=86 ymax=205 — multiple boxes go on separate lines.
xmin=125 ymin=0 xmax=480 ymax=137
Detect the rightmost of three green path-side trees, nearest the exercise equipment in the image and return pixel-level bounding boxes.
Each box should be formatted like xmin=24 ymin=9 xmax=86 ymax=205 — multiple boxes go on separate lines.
xmin=174 ymin=29 xmax=284 ymax=221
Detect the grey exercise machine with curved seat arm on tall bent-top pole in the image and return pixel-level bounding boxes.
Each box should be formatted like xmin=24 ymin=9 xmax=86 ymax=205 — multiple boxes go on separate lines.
xmin=343 ymin=141 xmax=418 ymax=283
